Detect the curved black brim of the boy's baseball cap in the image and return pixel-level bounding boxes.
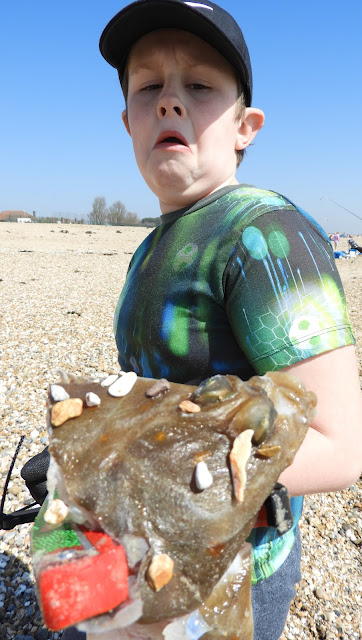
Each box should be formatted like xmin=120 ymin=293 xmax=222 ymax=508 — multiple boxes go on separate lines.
xmin=99 ymin=0 xmax=251 ymax=106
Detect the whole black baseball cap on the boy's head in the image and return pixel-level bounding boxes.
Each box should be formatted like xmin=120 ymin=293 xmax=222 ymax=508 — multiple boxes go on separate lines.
xmin=99 ymin=0 xmax=252 ymax=106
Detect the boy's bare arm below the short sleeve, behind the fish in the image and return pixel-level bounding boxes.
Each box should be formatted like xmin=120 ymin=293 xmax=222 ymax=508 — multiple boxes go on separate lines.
xmin=280 ymin=346 xmax=362 ymax=496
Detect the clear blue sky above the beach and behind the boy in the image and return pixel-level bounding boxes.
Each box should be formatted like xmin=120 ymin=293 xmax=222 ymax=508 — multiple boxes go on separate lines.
xmin=0 ymin=0 xmax=362 ymax=233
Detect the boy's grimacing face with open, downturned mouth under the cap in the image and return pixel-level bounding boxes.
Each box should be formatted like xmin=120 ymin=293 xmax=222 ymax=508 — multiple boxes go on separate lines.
xmin=123 ymin=29 xmax=260 ymax=213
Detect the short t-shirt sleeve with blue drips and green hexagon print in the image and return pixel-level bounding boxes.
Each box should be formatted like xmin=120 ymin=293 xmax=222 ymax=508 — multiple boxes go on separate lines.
xmin=223 ymin=208 xmax=354 ymax=375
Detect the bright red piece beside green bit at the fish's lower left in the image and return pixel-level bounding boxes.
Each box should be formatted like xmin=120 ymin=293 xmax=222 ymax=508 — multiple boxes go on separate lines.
xmin=38 ymin=531 xmax=128 ymax=631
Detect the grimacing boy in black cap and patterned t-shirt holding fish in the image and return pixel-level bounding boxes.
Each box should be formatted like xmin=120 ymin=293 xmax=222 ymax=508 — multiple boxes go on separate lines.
xmin=64 ymin=0 xmax=361 ymax=640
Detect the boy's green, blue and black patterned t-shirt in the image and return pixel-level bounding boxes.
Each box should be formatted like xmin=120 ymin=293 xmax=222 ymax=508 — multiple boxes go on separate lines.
xmin=115 ymin=185 xmax=354 ymax=582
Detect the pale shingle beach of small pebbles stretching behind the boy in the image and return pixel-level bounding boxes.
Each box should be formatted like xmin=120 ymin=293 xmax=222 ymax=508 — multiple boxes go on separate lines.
xmin=0 ymin=223 xmax=362 ymax=640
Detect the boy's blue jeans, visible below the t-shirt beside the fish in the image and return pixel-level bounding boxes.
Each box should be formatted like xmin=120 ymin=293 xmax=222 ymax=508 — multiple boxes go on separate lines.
xmin=62 ymin=526 xmax=301 ymax=640
